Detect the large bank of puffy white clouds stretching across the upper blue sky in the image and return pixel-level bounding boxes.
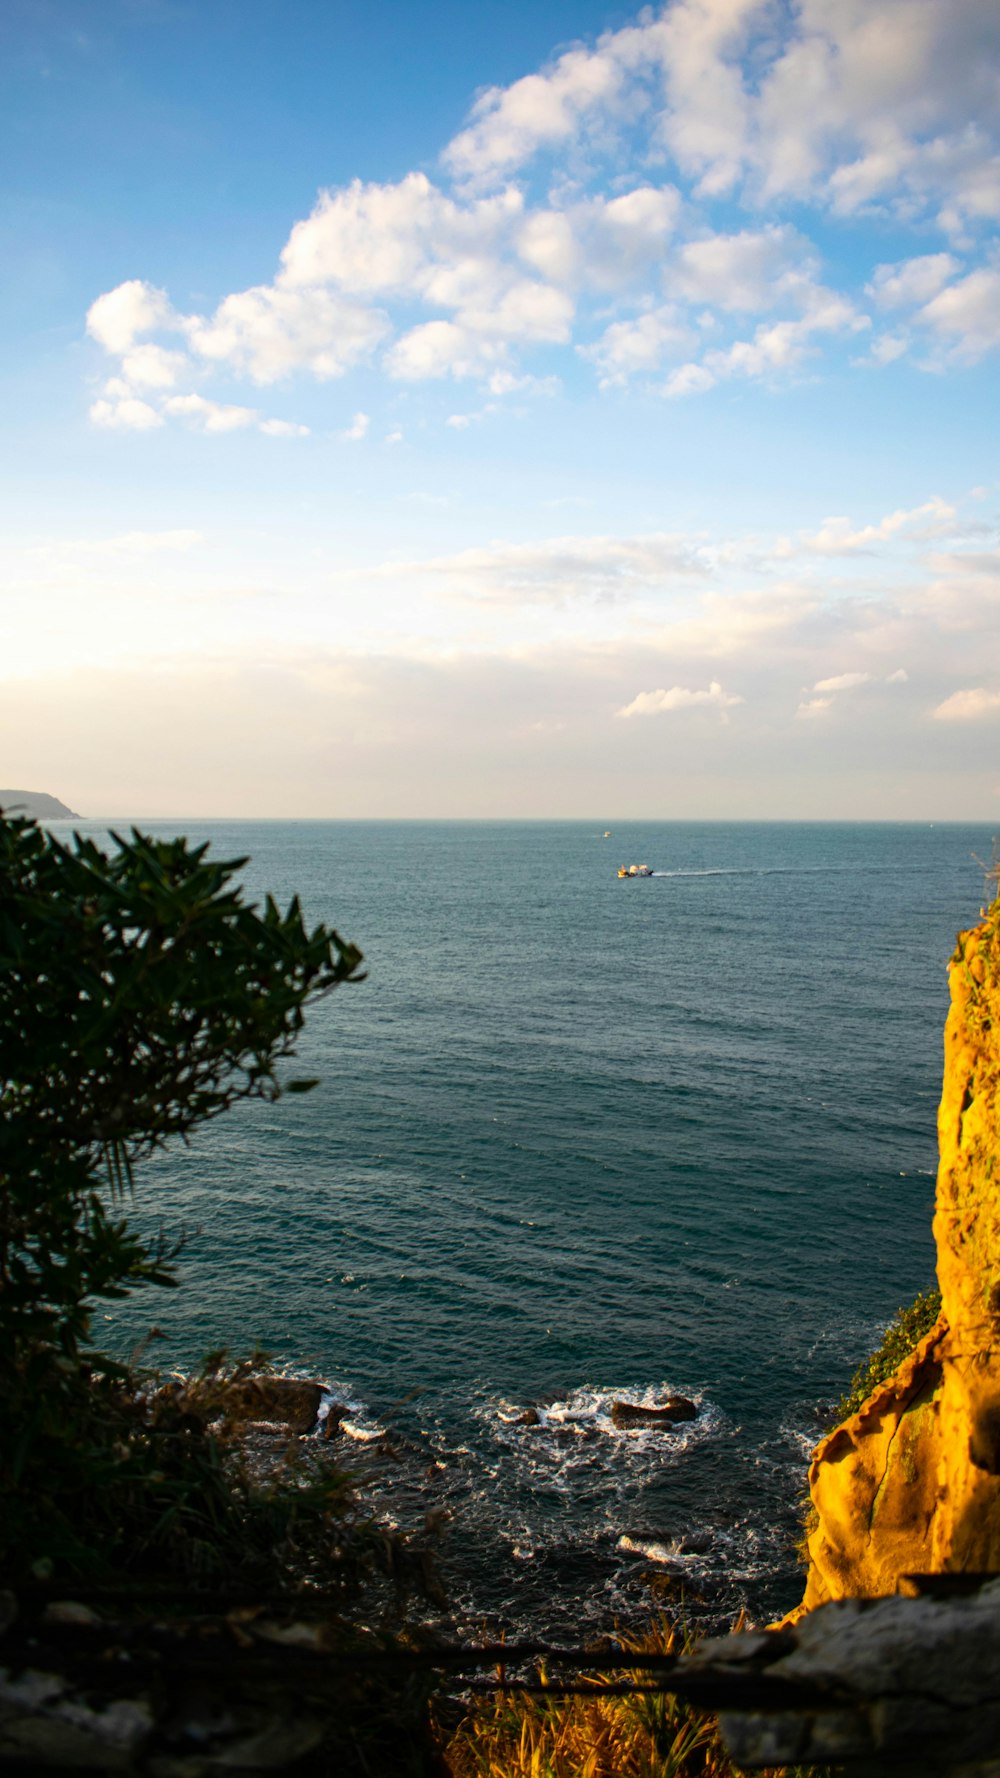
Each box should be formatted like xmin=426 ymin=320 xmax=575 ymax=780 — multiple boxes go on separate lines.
xmin=87 ymin=0 xmax=1000 ymax=430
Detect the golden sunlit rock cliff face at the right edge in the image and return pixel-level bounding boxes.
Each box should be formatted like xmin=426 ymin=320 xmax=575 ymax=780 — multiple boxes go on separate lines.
xmin=795 ymin=900 xmax=1000 ymax=1616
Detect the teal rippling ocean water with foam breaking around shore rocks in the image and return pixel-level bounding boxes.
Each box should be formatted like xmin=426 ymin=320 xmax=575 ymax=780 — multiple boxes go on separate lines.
xmin=89 ymin=821 xmax=991 ymax=1636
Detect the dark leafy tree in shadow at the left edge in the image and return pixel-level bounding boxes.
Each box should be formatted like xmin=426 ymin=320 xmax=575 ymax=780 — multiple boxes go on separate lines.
xmin=0 ymin=813 xmax=361 ymax=1570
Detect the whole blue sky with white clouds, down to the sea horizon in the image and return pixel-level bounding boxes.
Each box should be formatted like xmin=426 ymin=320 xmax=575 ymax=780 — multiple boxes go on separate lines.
xmin=0 ymin=0 xmax=1000 ymax=820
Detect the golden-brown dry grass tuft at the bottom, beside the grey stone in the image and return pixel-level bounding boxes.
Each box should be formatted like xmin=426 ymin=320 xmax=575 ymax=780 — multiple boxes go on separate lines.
xmin=438 ymin=1623 xmax=820 ymax=1778
